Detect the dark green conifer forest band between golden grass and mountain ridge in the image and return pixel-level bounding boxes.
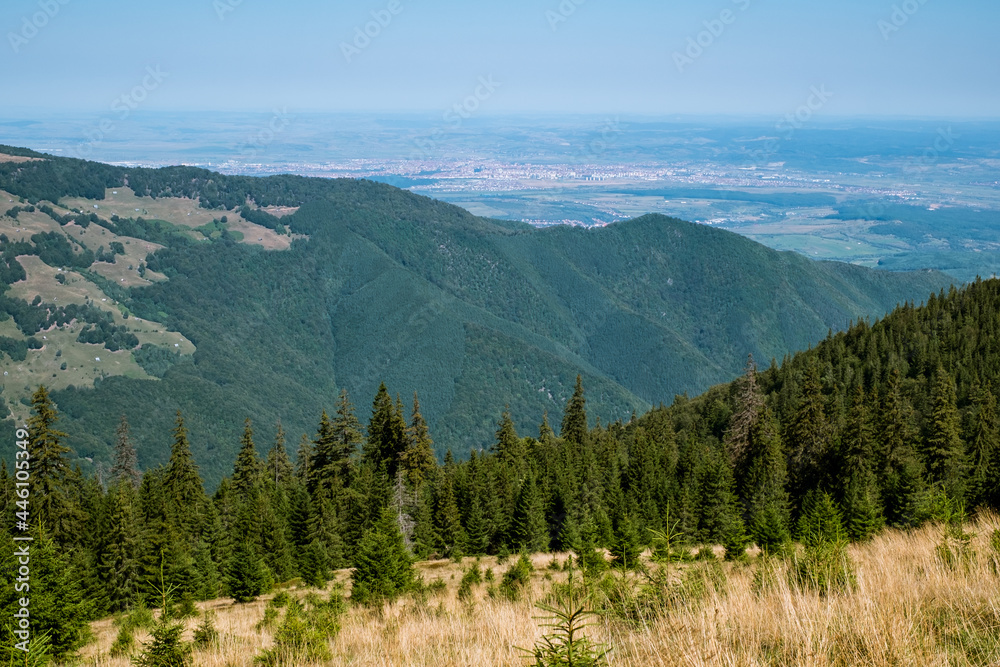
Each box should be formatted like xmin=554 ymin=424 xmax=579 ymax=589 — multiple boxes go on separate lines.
xmin=0 ymin=281 xmax=1000 ymax=664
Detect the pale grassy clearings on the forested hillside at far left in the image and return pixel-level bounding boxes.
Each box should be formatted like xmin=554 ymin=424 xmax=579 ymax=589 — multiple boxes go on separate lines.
xmin=0 ymin=185 xmax=306 ymax=421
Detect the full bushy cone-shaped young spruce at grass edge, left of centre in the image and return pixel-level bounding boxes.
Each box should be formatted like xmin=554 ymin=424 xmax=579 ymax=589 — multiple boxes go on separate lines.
xmin=351 ymin=509 xmax=414 ymax=604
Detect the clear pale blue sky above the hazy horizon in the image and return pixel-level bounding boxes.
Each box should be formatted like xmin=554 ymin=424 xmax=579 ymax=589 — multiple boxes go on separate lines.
xmin=0 ymin=0 xmax=1000 ymax=118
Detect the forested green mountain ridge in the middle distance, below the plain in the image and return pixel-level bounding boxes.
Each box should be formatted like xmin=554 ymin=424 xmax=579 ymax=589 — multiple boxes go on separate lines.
xmin=0 ymin=147 xmax=951 ymax=484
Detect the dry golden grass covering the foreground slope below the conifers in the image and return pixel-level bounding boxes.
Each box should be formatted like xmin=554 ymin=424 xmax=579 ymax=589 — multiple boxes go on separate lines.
xmin=84 ymin=515 xmax=1000 ymax=667
